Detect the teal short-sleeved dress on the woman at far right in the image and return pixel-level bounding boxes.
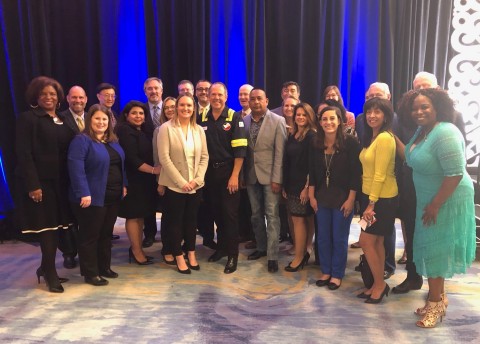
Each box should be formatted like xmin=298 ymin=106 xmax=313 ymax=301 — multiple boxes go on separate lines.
xmin=405 ymin=122 xmax=476 ymax=278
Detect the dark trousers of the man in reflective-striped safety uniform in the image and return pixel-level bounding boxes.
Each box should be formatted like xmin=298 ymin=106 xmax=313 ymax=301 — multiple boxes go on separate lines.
xmin=205 ymin=161 xmax=240 ymax=256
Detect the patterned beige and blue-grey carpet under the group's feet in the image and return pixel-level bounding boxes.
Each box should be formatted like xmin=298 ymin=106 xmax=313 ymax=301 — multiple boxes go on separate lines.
xmin=0 ymin=220 xmax=480 ymax=344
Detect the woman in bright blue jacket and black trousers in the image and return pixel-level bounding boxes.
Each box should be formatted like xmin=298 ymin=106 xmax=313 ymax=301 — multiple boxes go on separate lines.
xmin=68 ymin=104 xmax=127 ymax=286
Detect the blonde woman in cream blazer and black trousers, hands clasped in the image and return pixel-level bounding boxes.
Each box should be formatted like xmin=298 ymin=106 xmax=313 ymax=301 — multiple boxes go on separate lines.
xmin=157 ymin=94 xmax=208 ymax=274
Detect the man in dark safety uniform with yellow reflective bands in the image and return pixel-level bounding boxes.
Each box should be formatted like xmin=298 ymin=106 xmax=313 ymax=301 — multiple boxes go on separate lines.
xmin=199 ymin=82 xmax=248 ymax=274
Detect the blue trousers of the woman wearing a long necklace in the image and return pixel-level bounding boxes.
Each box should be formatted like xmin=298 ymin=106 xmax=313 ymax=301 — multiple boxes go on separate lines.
xmin=316 ymin=205 xmax=353 ymax=279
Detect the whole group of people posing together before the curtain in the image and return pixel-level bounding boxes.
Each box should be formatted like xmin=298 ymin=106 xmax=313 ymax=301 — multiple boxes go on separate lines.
xmin=16 ymin=72 xmax=475 ymax=327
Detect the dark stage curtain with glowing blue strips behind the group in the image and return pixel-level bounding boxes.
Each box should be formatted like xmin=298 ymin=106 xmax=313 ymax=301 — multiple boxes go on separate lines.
xmin=0 ymin=0 xmax=453 ymax=185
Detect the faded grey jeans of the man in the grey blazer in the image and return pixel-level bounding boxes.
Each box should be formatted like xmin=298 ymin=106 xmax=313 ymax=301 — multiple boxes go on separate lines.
xmin=247 ymin=182 xmax=280 ymax=260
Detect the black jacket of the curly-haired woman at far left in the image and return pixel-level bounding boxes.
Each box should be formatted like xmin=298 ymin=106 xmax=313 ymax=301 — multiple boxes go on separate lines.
xmin=15 ymin=108 xmax=75 ymax=192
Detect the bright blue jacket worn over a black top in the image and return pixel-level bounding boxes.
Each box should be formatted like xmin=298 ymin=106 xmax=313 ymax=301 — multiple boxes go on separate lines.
xmin=68 ymin=134 xmax=127 ymax=207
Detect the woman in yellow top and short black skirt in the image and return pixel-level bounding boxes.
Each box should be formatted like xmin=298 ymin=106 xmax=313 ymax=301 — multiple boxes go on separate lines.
xmin=358 ymin=98 xmax=398 ymax=304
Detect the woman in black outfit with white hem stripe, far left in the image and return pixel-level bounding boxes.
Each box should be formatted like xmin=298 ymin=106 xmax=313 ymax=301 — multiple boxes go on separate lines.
xmin=15 ymin=76 xmax=75 ymax=293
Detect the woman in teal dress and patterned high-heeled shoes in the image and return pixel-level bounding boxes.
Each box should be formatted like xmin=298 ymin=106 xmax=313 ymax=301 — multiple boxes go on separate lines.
xmin=397 ymin=89 xmax=475 ymax=327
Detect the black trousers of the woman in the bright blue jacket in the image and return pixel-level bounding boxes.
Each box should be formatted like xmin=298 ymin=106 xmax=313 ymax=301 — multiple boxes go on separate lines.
xmin=72 ymin=202 xmax=120 ymax=277
